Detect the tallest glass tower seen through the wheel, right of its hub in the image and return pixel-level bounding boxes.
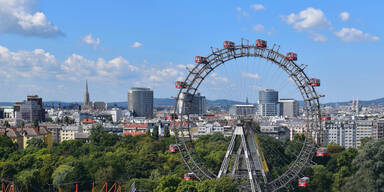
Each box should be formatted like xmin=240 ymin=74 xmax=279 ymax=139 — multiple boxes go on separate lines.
xmin=259 ymin=89 xmax=280 ymax=117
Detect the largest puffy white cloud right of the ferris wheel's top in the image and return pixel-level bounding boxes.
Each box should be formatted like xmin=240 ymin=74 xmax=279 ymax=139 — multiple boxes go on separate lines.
xmin=283 ymin=7 xmax=331 ymax=31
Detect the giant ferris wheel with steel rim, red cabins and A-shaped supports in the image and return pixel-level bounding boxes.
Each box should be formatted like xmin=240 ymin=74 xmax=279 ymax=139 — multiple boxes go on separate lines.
xmin=170 ymin=39 xmax=322 ymax=192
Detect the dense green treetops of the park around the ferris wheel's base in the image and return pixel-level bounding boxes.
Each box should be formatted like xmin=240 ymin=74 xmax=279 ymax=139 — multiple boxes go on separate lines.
xmin=0 ymin=127 xmax=384 ymax=192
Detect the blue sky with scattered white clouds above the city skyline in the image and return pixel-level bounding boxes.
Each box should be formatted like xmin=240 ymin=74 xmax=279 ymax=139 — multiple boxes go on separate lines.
xmin=0 ymin=0 xmax=384 ymax=102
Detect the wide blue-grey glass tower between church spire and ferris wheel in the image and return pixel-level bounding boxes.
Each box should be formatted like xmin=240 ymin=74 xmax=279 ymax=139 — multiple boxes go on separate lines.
xmin=128 ymin=87 xmax=153 ymax=118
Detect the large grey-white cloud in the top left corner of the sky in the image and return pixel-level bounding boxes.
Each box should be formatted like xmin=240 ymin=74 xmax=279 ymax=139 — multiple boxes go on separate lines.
xmin=0 ymin=0 xmax=64 ymax=38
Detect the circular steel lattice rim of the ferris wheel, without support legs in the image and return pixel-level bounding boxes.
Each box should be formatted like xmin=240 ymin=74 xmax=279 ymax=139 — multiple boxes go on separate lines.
xmin=172 ymin=39 xmax=323 ymax=191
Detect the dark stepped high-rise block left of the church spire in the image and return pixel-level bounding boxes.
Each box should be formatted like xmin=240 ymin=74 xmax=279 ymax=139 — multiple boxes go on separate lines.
xmin=19 ymin=95 xmax=45 ymax=122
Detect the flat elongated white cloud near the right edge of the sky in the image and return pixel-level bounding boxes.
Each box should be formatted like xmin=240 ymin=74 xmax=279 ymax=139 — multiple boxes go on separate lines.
xmin=335 ymin=28 xmax=380 ymax=42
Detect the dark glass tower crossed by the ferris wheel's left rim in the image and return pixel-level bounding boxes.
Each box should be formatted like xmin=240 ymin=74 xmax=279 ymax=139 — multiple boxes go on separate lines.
xmin=177 ymin=93 xmax=207 ymax=115
